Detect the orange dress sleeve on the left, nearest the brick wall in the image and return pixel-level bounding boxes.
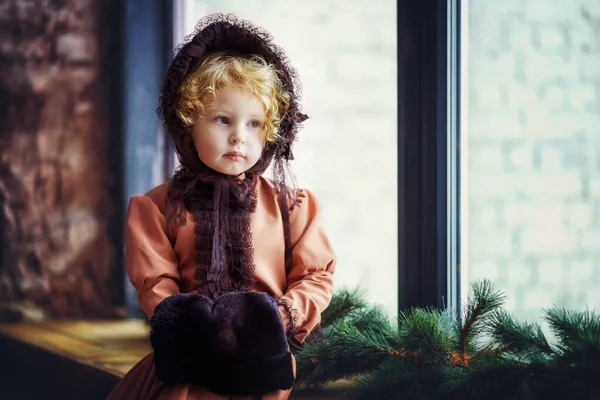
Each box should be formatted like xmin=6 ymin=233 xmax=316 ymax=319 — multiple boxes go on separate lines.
xmin=125 ymin=195 xmax=181 ymax=319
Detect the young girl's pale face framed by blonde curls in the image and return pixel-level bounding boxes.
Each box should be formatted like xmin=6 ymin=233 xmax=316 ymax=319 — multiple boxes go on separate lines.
xmin=192 ymin=88 xmax=265 ymax=176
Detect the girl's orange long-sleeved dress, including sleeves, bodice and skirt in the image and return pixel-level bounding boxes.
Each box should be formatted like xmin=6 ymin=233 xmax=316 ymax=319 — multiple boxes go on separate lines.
xmin=107 ymin=177 xmax=335 ymax=400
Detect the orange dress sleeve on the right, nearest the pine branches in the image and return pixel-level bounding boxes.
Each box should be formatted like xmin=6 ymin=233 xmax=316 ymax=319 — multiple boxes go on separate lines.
xmin=279 ymin=190 xmax=336 ymax=343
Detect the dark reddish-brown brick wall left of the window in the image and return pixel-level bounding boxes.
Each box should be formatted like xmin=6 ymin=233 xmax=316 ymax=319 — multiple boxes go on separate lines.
xmin=0 ymin=0 xmax=123 ymax=320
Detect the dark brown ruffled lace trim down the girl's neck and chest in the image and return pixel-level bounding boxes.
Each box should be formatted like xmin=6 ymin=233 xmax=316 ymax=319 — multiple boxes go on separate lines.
xmin=172 ymin=169 xmax=258 ymax=298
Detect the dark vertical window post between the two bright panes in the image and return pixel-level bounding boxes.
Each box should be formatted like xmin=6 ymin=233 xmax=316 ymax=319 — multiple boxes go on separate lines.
xmin=397 ymin=0 xmax=461 ymax=311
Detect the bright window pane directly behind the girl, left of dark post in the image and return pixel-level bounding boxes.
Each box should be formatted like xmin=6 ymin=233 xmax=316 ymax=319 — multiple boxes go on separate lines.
xmin=182 ymin=0 xmax=398 ymax=314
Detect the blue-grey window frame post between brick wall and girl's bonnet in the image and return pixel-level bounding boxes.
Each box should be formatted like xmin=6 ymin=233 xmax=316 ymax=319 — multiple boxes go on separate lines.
xmin=121 ymin=0 xmax=173 ymax=318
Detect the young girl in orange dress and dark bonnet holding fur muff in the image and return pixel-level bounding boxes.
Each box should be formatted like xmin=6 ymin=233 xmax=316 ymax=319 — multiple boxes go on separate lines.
xmin=109 ymin=14 xmax=335 ymax=400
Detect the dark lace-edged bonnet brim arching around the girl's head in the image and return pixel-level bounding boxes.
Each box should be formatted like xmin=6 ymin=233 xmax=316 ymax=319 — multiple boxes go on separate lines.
xmin=157 ymin=14 xmax=308 ymax=174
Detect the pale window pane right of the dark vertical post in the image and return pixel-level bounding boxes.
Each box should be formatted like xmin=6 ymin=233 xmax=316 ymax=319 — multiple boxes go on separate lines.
xmin=462 ymin=0 xmax=600 ymax=320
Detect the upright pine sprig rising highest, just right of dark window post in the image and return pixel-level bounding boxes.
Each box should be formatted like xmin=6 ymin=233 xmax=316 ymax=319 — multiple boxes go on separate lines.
xmin=458 ymin=280 xmax=505 ymax=354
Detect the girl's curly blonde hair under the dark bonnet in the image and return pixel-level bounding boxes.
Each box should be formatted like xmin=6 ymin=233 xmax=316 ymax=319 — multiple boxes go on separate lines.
xmin=177 ymin=52 xmax=291 ymax=142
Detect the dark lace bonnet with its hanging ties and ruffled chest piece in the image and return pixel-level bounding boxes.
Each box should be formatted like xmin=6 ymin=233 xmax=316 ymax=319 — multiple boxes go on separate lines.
xmin=157 ymin=14 xmax=307 ymax=304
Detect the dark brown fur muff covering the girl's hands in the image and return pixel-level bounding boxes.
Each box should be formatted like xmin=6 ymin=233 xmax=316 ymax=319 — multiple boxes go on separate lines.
xmin=150 ymin=292 xmax=294 ymax=395
